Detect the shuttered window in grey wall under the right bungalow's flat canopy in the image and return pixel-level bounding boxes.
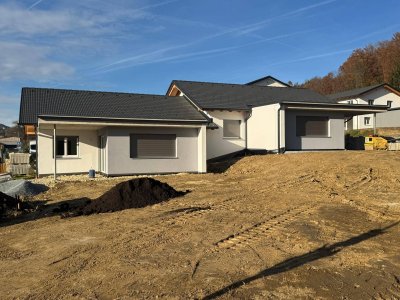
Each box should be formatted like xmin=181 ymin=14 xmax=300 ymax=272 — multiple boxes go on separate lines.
xmin=296 ymin=116 xmax=329 ymax=137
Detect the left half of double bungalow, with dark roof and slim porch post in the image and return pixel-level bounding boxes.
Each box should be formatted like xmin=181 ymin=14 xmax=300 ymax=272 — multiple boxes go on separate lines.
xmin=19 ymin=88 xmax=211 ymax=176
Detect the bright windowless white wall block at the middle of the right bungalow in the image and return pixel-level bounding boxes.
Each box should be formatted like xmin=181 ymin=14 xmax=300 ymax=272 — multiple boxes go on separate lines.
xmin=247 ymin=104 xmax=285 ymax=151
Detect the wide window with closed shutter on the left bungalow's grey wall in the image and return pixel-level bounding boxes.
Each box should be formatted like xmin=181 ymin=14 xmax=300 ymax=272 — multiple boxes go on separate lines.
xmin=130 ymin=134 xmax=176 ymax=158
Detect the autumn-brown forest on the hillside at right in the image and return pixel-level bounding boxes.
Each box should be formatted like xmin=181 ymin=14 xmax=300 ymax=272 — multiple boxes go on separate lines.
xmin=295 ymin=32 xmax=400 ymax=95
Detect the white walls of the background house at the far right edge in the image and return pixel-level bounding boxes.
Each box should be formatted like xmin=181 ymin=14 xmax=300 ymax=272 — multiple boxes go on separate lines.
xmin=339 ymin=87 xmax=400 ymax=129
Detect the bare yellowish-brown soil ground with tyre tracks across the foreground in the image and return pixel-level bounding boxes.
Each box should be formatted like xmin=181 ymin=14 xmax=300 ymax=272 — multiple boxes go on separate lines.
xmin=0 ymin=151 xmax=400 ymax=299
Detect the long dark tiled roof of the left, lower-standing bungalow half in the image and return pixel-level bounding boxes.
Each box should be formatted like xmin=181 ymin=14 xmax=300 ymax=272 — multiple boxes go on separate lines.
xmin=19 ymin=88 xmax=209 ymax=124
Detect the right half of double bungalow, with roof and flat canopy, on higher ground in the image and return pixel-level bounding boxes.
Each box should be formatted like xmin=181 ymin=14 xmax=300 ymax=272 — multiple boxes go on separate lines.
xmin=167 ymin=80 xmax=387 ymax=159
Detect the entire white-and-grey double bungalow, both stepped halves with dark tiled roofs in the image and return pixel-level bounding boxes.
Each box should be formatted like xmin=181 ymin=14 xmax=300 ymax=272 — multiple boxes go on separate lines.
xmin=19 ymin=78 xmax=387 ymax=176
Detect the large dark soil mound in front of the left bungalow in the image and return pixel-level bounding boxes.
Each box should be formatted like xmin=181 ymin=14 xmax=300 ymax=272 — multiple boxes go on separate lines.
xmin=81 ymin=178 xmax=186 ymax=215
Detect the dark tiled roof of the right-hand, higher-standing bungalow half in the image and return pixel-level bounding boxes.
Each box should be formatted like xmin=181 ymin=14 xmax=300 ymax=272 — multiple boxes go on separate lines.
xmin=170 ymin=80 xmax=336 ymax=110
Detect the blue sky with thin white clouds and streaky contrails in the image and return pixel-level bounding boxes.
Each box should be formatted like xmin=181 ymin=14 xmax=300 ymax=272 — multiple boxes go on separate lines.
xmin=0 ymin=0 xmax=400 ymax=124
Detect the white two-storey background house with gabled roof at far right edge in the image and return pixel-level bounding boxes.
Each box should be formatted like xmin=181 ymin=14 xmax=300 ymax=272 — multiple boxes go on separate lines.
xmin=328 ymin=83 xmax=400 ymax=130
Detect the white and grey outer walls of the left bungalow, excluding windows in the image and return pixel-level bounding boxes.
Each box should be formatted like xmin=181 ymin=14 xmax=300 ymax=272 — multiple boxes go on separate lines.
xmin=37 ymin=125 xmax=207 ymax=176
